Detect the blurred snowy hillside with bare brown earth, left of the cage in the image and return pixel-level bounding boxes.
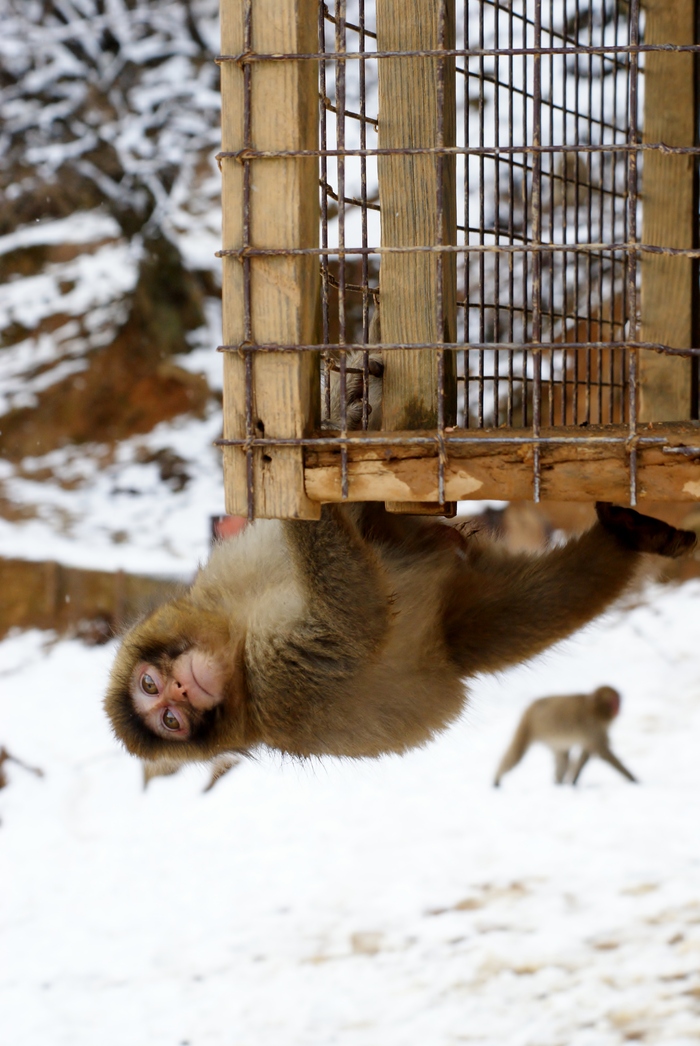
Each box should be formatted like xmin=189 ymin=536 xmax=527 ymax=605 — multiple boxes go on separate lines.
xmin=0 ymin=0 xmax=220 ymax=470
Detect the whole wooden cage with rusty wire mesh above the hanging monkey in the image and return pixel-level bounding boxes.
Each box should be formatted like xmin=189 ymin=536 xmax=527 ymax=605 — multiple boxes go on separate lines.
xmin=215 ymin=0 xmax=700 ymax=517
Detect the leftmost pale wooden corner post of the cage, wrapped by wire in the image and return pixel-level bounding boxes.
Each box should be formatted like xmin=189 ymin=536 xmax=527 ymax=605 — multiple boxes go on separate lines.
xmin=221 ymin=0 xmax=320 ymax=519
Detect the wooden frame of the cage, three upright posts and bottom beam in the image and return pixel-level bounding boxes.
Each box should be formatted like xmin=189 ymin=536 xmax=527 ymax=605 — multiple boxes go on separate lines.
xmin=220 ymin=0 xmax=700 ymax=519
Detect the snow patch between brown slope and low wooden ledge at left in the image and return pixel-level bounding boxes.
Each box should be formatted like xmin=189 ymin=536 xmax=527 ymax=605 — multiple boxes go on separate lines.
xmin=0 ymin=403 xmax=225 ymax=577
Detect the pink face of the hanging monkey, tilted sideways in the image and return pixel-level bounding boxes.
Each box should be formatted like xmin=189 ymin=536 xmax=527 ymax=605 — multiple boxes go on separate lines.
xmin=131 ymin=647 xmax=225 ymax=741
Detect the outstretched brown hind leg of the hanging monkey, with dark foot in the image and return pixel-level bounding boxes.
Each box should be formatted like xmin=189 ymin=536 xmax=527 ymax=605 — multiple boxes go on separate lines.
xmin=445 ymin=504 xmax=695 ymax=675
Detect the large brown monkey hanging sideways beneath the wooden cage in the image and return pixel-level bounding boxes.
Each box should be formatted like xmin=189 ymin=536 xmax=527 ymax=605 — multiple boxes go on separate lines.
xmin=106 ymin=503 xmax=695 ymax=763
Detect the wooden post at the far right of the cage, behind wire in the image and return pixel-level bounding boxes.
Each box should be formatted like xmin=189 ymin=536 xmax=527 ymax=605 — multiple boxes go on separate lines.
xmin=639 ymin=0 xmax=696 ymax=422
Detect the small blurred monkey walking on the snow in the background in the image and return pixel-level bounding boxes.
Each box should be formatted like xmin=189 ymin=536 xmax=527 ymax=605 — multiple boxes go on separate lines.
xmin=494 ymin=686 xmax=636 ymax=788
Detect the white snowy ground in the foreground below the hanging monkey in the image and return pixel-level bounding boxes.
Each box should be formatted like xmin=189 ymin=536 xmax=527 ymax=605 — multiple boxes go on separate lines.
xmin=0 ymin=582 xmax=700 ymax=1046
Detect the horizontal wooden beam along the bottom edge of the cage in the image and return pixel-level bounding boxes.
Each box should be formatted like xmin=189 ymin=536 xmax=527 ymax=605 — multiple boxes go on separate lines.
xmin=306 ymin=423 xmax=700 ymax=504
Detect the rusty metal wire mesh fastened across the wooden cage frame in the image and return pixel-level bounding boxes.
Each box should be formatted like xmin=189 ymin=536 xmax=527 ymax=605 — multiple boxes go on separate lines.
xmin=217 ymin=0 xmax=700 ymax=514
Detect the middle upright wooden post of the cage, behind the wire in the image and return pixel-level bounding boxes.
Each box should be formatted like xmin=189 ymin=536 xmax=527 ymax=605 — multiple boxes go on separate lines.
xmin=377 ymin=0 xmax=456 ymax=511
